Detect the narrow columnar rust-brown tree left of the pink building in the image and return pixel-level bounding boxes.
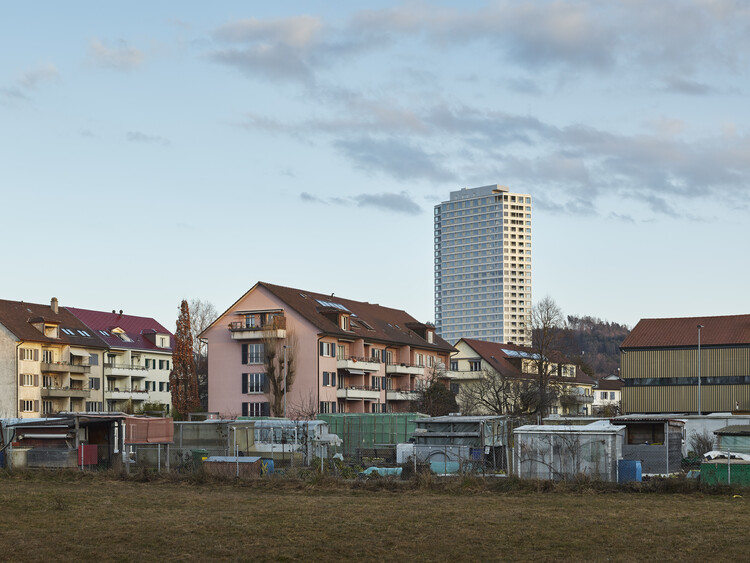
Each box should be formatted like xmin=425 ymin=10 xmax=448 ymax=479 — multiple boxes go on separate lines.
xmin=169 ymin=299 xmax=200 ymax=418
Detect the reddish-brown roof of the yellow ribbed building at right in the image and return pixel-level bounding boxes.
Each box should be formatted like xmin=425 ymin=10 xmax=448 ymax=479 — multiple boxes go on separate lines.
xmin=620 ymin=315 xmax=750 ymax=349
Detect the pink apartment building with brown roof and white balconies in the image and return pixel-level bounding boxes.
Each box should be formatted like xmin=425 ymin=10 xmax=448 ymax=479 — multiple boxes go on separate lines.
xmin=201 ymin=282 xmax=455 ymax=417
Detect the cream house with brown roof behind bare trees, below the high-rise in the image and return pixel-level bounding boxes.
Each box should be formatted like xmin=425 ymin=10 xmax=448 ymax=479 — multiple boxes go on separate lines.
xmin=446 ymin=338 xmax=595 ymax=416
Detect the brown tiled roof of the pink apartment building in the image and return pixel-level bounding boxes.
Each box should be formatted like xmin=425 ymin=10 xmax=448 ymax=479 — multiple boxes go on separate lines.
xmin=226 ymin=282 xmax=455 ymax=352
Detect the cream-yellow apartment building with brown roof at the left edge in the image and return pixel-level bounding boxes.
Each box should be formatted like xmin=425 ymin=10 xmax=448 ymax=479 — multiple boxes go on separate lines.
xmin=0 ymin=298 xmax=107 ymax=418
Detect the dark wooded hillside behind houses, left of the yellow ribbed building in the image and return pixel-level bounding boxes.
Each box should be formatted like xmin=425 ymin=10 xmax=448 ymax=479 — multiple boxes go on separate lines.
xmin=560 ymin=315 xmax=630 ymax=379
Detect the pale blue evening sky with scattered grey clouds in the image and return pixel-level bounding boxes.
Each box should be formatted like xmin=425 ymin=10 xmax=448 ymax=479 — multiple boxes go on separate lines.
xmin=0 ymin=0 xmax=750 ymax=329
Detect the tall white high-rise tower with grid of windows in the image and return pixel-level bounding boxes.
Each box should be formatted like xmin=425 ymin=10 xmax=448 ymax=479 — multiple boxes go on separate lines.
xmin=434 ymin=185 xmax=532 ymax=346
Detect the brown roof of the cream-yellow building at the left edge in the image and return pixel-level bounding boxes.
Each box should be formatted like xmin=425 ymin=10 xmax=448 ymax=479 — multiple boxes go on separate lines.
xmin=0 ymin=299 xmax=107 ymax=348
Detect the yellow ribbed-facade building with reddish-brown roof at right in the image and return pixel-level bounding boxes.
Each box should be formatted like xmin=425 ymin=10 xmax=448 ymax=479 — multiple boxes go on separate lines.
xmin=620 ymin=315 xmax=750 ymax=414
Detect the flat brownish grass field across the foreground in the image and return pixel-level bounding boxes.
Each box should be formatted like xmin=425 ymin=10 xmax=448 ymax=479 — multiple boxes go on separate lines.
xmin=0 ymin=473 xmax=750 ymax=561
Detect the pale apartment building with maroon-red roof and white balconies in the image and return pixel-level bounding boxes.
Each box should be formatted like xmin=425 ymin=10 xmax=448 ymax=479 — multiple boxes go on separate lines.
xmin=66 ymin=307 xmax=174 ymax=413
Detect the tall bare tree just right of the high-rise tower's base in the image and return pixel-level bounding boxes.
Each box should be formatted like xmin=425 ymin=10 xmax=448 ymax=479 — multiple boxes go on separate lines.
xmin=531 ymin=296 xmax=564 ymax=418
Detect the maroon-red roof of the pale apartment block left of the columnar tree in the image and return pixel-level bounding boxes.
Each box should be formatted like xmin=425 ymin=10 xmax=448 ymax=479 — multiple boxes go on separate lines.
xmin=65 ymin=307 xmax=174 ymax=353
